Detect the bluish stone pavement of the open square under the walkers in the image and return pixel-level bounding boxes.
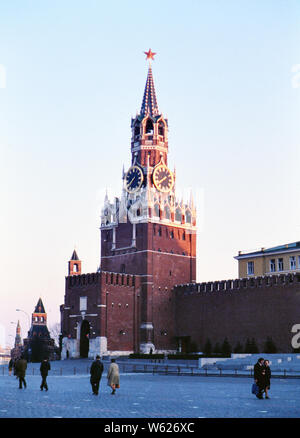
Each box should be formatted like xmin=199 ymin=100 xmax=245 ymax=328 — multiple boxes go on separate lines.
xmin=0 ymin=361 xmax=300 ymax=418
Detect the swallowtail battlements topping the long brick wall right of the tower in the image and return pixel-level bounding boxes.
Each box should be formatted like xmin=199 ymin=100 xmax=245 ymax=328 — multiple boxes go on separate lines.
xmin=174 ymin=273 xmax=300 ymax=295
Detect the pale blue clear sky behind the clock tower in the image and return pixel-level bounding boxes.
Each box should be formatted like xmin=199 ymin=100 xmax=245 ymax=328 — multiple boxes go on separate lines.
xmin=0 ymin=0 xmax=300 ymax=342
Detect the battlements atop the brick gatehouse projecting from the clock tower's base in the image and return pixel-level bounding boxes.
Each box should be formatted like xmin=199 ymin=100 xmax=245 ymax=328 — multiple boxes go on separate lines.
xmin=66 ymin=271 xmax=137 ymax=287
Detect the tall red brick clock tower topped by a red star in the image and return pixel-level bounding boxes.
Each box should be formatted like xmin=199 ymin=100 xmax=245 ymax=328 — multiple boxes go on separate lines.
xmin=101 ymin=49 xmax=196 ymax=352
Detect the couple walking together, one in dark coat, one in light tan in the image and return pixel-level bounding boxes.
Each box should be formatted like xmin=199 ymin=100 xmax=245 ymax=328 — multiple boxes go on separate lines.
xmin=90 ymin=355 xmax=120 ymax=395
